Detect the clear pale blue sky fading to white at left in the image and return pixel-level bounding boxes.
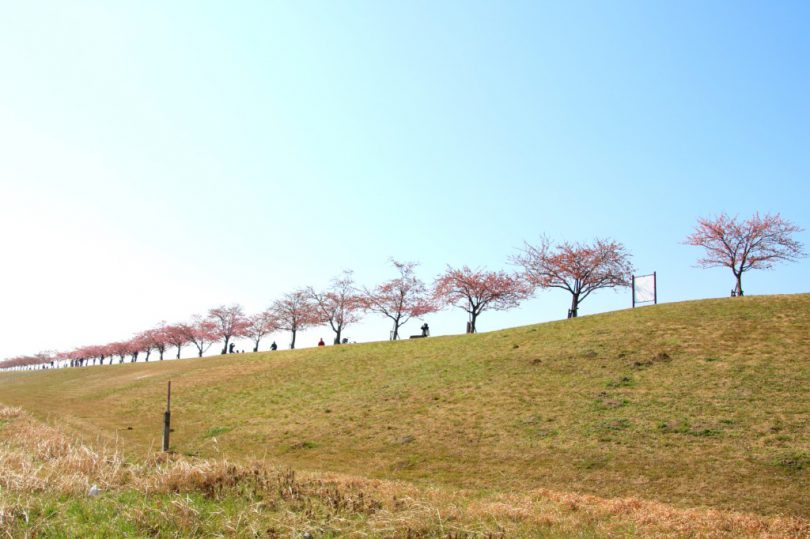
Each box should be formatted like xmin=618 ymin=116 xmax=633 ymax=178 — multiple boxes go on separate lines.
xmin=0 ymin=1 xmax=810 ymax=359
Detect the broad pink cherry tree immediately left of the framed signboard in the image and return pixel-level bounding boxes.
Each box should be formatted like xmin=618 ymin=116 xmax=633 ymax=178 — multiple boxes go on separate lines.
xmin=512 ymin=237 xmax=633 ymax=317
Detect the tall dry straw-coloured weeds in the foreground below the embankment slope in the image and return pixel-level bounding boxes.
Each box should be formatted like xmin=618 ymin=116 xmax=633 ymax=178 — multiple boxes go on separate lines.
xmin=0 ymin=406 xmax=810 ymax=537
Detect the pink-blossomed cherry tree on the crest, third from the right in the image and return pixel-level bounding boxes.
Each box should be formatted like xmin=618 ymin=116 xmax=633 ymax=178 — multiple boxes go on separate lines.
xmin=434 ymin=266 xmax=532 ymax=333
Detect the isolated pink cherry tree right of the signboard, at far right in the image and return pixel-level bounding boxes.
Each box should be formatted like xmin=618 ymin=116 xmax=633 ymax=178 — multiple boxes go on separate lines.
xmin=685 ymin=213 xmax=806 ymax=296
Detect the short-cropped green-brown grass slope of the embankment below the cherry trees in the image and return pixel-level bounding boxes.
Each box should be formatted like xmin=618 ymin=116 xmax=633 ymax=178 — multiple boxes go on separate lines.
xmin=0 ymin=294 xmax=810 ymax=536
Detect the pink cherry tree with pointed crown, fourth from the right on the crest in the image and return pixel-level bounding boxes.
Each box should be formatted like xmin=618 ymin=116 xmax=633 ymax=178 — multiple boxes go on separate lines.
xmin=362 ymin=259 xmax=438 ymax=341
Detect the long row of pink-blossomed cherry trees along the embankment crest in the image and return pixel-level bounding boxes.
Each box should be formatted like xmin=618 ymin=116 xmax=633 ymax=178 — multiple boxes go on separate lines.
xmin=0 ymin=214 xmax=804 ymax=368
